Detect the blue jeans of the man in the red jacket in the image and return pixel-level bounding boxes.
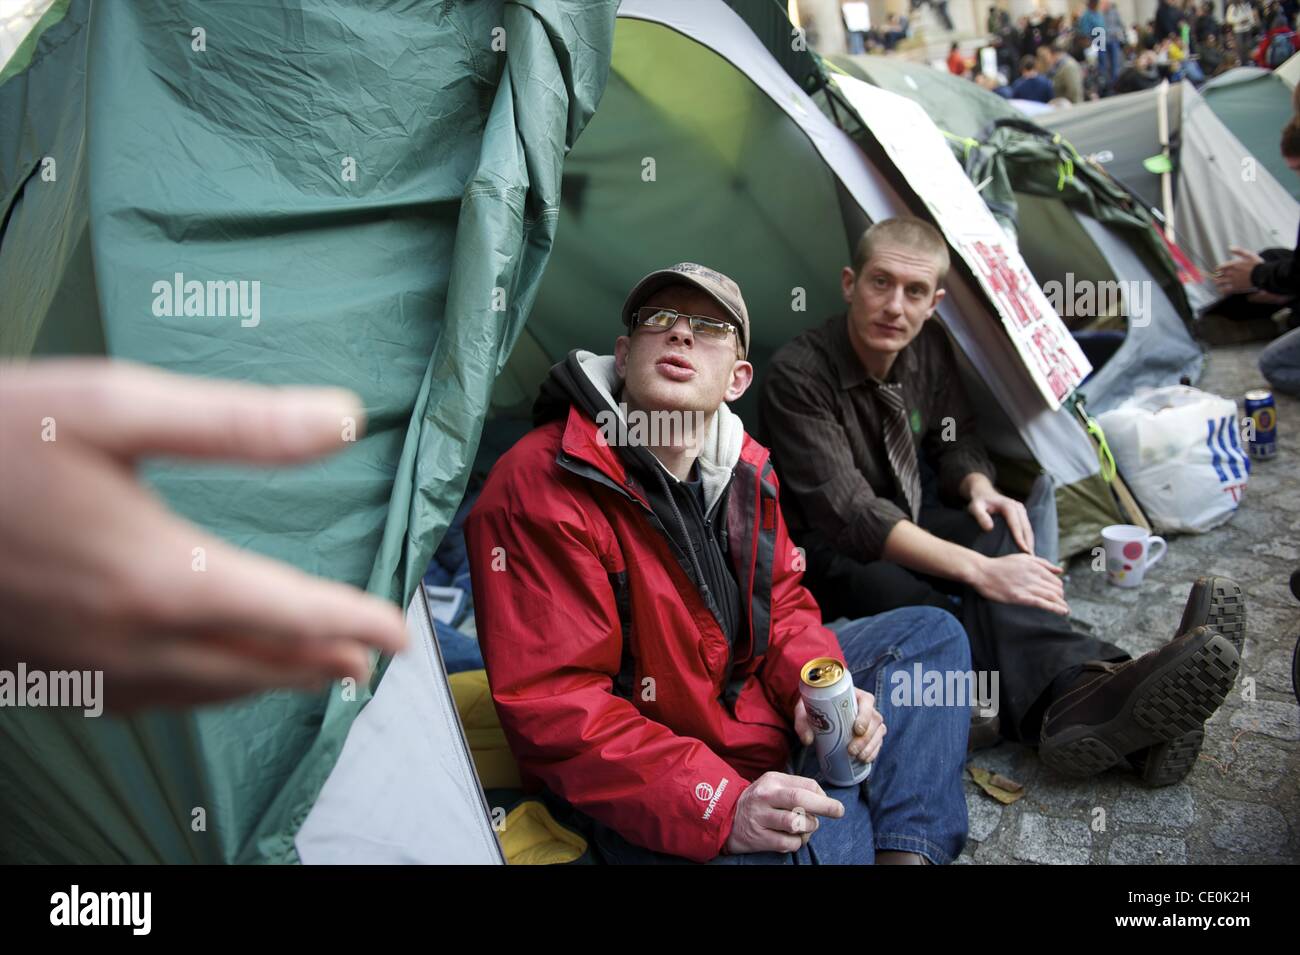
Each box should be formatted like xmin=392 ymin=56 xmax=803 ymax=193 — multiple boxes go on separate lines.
xmin=593 ymin=607 xmax=971 ymax=865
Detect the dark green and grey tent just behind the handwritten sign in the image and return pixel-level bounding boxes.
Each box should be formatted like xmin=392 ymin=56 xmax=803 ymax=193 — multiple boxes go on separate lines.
xmin=831 ymin=56 xmax=1203 ymax=413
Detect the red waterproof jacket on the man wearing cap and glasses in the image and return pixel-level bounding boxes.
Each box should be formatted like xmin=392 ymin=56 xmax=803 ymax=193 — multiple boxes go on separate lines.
xmin=465 ymin=356 xmax=842 ymax=861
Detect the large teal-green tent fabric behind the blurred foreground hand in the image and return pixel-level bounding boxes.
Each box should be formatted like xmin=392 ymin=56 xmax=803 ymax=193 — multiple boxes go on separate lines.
xmin=0 ymin=0 xmax=616 ymax=861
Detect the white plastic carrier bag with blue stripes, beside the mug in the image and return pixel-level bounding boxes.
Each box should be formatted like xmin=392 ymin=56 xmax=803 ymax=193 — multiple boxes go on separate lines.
xmin=1097 ymin=385 xmax=1251 ymax=534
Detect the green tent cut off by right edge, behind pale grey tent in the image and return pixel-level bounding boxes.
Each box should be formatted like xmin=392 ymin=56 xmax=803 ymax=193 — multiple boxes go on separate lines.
xmin=1201 ymin=66 xmax=1300 ymax=200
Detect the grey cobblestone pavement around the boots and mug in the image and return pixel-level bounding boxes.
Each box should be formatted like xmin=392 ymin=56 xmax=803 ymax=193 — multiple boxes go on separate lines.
xmin=958 ymin=344 xmax=1300 ymax=864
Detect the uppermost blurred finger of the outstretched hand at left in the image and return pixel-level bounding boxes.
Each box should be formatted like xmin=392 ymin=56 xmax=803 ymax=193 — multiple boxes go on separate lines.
xmin=19 ymin=361 xmax=365 ymax=464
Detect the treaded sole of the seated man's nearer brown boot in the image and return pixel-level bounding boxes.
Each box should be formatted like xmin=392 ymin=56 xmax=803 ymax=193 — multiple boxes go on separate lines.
xmin=1039 ymin=633 xmax=1242 ymax=777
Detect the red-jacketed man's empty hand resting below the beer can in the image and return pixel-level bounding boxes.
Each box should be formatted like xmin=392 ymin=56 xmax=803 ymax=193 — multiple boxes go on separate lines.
xmin=725 ymin=773 xmax=844 ymax=855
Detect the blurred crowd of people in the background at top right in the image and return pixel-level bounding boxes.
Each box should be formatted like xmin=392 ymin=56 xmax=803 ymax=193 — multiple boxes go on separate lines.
xmin=850 ymin=0 xmax=1300 ymax=103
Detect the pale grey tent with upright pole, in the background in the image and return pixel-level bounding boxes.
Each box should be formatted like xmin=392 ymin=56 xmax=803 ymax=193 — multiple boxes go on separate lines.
xmin=1040 ymin=81 xmax=1300 ymax=280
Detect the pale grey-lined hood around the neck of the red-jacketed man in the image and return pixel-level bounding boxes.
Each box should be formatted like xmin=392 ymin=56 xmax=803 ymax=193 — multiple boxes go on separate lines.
xmin=533 ymin=350 xmax=745 ymax=509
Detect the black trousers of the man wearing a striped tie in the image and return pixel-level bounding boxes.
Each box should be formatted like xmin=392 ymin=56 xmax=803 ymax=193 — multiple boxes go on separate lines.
xmin=803 ymin=507 xmax=1128 ymax=743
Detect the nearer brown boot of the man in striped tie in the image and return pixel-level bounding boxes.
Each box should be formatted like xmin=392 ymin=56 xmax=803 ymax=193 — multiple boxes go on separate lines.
xmin=1039 ymin=626 xmax=1242 ymax=776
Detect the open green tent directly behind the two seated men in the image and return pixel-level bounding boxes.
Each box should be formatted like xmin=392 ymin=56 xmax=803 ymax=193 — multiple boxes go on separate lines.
xmin=480 ymin=0 xmax=1138 ymax=571
